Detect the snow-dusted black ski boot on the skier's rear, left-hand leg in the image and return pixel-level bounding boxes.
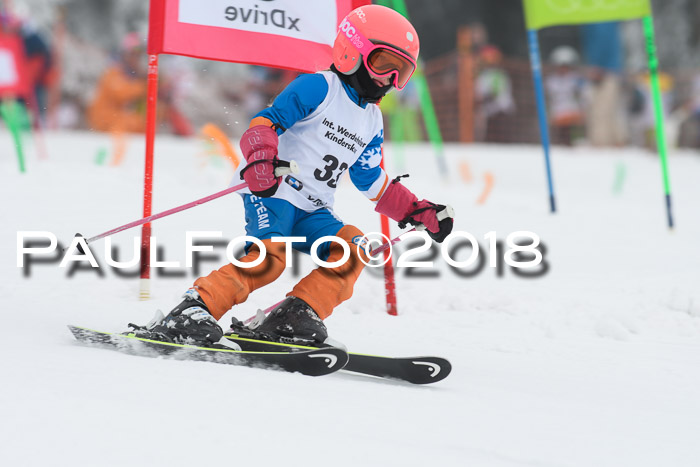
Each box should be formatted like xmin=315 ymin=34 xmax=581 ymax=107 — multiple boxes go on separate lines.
xmin=130 ymin=289 xmax=224 ymax=347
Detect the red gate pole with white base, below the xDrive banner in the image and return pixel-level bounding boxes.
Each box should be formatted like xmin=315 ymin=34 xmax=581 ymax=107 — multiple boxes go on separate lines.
xmin=139 ymin=54 xmax=158 ymax=300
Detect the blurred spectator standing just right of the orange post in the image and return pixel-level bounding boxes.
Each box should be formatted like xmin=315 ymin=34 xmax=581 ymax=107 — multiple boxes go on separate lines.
xmin=474 ymin=45 xmax=515 ymax=142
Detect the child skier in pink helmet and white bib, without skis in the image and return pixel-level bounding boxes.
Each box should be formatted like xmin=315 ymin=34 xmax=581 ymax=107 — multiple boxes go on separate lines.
xmin=137 ymin=5 xmax=453 ymax=346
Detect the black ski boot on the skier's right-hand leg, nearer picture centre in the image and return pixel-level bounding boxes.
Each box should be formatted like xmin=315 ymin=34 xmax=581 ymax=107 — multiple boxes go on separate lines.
xmin=253 ymin=297 xmax=328 ymax=346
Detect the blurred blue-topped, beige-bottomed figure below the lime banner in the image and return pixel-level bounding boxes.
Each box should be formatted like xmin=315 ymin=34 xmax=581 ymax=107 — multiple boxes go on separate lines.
xmin=581 ymin=22 xmax=627 ymax=146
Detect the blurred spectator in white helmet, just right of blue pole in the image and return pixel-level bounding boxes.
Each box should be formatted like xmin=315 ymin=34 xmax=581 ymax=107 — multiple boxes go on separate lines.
xmin=545 ymin=46 xmax=585 ymax=146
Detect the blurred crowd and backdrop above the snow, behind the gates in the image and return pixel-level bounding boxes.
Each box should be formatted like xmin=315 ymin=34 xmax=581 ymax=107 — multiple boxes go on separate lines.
xmin=0 ymin=0 xmax=700 ymax=148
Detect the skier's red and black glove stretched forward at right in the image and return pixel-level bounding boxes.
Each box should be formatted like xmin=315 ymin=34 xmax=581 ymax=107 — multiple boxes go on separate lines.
xmin=374 ymin=177 xmax=454 ymax=243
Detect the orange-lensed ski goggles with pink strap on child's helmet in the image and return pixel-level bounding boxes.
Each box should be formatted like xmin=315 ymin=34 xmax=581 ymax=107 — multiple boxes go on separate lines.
xmin=340 ymin=19 xmax=416 ymax=90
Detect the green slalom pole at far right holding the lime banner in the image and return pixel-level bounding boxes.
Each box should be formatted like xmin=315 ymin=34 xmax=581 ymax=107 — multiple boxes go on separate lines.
xmin=642 ymin=15 xmax=673 ymax=229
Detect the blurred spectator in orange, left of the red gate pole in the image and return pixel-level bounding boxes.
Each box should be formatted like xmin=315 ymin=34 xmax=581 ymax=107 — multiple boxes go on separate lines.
xmin=88 ymin=33 xmax=146 ymax=133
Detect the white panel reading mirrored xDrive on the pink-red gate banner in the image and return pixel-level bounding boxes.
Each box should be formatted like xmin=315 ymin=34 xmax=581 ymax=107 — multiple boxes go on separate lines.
xmin=178 ymin=0 xmax=338 ymax=47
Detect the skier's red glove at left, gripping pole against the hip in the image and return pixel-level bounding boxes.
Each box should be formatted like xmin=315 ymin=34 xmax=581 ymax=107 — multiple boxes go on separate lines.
xmin=241 ymin=125 xmax=282 ymax=198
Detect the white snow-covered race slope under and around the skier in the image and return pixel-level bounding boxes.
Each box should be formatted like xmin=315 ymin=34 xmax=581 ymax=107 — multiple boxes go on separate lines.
xmin=0 ymin=130 xmax=700 ymax=467
